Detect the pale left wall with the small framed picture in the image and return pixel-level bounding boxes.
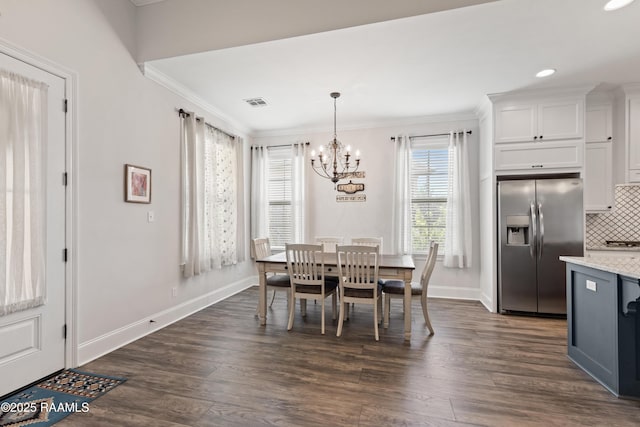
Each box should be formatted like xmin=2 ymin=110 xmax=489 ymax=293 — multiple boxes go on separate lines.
xmin=0 ymin=0 xmax=253 ymax=363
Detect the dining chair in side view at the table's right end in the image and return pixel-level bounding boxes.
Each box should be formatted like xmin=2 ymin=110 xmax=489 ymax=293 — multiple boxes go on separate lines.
xmin=382 ymin=242 xmax=438 ymax=335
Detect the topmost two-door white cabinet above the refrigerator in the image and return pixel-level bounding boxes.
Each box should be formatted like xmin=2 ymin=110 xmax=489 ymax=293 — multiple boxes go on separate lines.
xmin=494 ymin=98 xmax=584 ymax=143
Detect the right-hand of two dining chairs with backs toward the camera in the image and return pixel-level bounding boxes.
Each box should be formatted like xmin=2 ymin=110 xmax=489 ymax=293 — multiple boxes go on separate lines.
xmin=336 ymin=245 xmax=382 ymax=341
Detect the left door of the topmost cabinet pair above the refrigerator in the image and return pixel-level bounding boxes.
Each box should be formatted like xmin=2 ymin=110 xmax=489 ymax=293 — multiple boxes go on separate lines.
xmin=494 ymin=104 xmax=538 ymax=143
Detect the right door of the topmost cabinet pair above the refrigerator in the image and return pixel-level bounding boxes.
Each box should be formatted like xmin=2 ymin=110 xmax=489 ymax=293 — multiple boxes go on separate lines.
xmin=537 ymin=99 xmax=584 ymax=141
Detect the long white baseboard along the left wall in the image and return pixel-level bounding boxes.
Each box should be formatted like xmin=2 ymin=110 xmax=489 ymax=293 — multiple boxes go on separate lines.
xmin=78 ymin=278 xmax=255 ymax=365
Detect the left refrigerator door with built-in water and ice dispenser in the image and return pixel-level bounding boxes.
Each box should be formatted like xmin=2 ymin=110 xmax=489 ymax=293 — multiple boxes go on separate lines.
xmin=498 ymin=180 xmax=537 ymax=312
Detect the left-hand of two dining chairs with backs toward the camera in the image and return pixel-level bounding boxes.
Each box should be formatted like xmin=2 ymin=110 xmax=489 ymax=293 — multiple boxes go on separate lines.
xmin=285 ymin=244 xmax=338 ymax=335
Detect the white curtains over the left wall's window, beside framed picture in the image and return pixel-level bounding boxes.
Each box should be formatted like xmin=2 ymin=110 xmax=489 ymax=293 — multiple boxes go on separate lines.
xmin=181 ymin=113 xmax=238 ymax=277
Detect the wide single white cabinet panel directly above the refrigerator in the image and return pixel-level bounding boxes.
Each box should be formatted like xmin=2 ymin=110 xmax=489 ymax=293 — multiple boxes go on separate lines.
xmin=494 ymin=140 xmax=584 ymax=171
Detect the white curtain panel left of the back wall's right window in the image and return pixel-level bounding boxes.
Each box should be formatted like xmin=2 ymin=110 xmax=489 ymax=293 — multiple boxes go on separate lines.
xmin=392 ymin=135 xmax=412 ymax=254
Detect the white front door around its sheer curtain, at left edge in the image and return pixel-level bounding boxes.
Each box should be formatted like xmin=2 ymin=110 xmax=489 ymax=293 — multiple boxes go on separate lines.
xmin=0 ymin=53 xmax=65 ymax=396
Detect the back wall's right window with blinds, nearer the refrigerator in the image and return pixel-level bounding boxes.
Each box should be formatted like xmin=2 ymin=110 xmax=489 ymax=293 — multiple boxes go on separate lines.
xmin=410 ymin=139 xmax=449 ymax=253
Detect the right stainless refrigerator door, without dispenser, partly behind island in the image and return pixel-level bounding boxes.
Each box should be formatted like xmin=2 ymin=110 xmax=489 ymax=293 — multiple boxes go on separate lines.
xmin=536 ymin=179 xmax=584 ymax=314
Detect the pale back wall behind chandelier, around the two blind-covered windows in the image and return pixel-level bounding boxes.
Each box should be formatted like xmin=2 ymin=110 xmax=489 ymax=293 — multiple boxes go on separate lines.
xmin=253 ymin=115 xmax=480 ymax=299
